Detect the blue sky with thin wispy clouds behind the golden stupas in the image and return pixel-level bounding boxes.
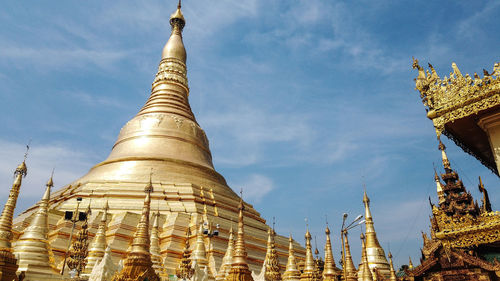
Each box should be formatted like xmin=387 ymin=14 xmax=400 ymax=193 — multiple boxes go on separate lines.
xmin=0 ymin=0 xmax=500 ymax=266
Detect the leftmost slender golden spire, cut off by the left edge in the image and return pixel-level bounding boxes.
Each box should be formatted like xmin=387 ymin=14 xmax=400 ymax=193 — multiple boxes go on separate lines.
xmin=0 ymin=161 xmax=28 ymax=281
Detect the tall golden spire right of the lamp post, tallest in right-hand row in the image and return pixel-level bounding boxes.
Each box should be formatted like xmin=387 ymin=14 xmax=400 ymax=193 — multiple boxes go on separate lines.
xmin=364 ymin=190 xmax=390 ymax=278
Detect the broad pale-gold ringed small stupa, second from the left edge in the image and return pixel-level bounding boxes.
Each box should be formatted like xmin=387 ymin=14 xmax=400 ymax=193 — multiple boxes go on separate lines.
xmin=15 ymin=174 xmax=58 ymax=279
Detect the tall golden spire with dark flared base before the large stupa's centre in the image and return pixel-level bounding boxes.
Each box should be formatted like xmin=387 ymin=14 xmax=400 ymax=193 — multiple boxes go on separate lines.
xmin=113 ymin=175 xmax=160 ymax=281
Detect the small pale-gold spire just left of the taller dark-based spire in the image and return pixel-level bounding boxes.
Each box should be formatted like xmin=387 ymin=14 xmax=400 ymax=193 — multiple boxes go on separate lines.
xmin=85 ymin=200 xmax=109 ymax=274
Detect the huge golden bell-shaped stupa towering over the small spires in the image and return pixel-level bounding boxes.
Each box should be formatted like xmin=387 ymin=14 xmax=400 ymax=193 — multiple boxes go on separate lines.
xmin=14 ymin=1 xmax=305 ymax=274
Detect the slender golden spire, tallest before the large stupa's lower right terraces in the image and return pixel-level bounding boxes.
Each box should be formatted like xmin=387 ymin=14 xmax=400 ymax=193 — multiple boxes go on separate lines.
xmin=226 ymin=192 xmax=253 ymax=281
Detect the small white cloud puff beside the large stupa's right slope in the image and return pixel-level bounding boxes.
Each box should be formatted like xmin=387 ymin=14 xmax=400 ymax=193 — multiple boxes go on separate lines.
xmin=230 ymin=174 xmax=274 ymax=203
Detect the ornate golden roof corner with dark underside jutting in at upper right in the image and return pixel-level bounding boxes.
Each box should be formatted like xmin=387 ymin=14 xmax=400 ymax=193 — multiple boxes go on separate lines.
xmin=413 ymin=59 xmax=500 ymax=175
